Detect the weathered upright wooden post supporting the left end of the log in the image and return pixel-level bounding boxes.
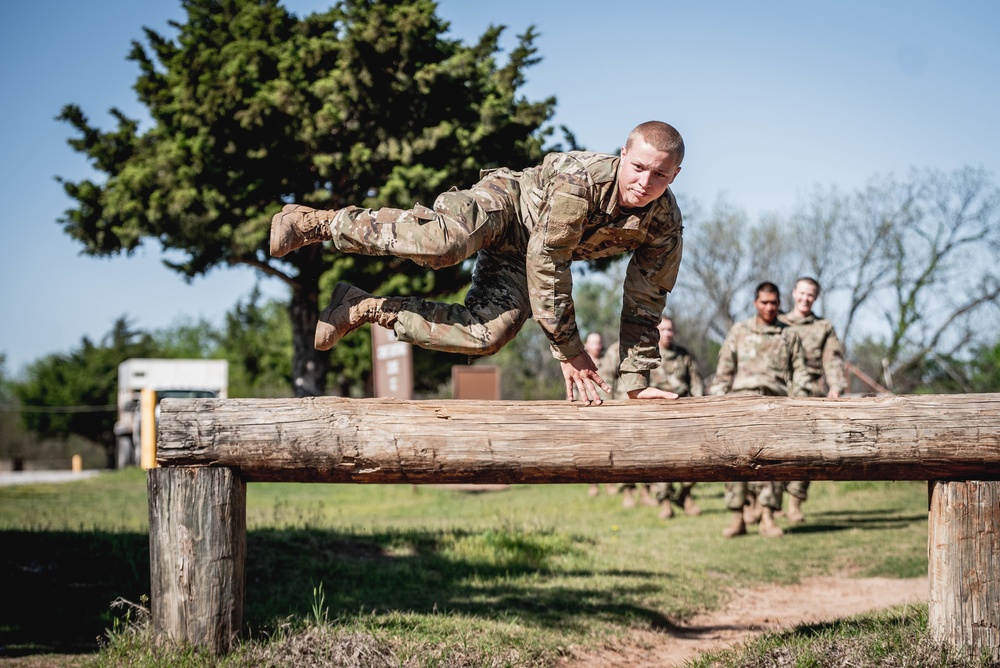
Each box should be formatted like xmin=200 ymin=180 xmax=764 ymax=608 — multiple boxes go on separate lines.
xmin=147 ymin=467 xmax=246 ymax=653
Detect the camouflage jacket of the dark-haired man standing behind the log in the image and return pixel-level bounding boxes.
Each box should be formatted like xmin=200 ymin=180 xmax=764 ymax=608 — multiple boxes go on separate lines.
xmin=709 ymin=316 xmax=815 ymax=397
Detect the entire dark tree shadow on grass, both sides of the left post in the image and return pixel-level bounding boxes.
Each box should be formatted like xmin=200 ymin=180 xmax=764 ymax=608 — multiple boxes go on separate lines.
xmin=0 ymin=529 xmax=673 ymax=657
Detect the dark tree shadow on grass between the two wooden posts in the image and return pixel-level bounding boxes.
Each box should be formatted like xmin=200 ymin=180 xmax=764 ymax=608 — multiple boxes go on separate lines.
xmin=246 ymin=529 xmax=669 ymax=631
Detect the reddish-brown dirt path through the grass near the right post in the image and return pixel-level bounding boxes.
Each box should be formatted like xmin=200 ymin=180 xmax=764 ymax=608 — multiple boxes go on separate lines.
xmin=564 ymin=577 xmax=929 ymax=668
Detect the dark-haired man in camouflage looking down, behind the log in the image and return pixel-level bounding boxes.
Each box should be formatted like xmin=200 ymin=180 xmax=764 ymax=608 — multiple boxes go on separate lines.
xmin=709 ymin=281 xmax=812 ymax=538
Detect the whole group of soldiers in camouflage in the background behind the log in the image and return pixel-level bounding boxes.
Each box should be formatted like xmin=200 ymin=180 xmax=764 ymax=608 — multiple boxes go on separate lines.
xmin=585 ymin=277 xmax=847 ymax=538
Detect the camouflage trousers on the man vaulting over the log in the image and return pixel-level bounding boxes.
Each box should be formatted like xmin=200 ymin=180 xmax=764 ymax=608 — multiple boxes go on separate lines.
xmin=330 ymin=175 xmax=531 ymax=355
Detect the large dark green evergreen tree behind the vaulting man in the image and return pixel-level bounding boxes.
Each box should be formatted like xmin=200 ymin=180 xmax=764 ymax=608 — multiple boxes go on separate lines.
xmin=60 ymin=0 xmax=555 ymax=395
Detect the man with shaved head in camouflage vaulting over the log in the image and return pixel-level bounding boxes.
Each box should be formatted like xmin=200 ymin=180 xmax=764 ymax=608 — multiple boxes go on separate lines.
xmin=271 ymin=121 xmax=684 ymax=405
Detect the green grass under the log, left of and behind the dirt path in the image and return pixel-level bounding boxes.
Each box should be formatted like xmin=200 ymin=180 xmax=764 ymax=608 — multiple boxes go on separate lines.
xmin=0 ymin=470 xmax=927 ymax=666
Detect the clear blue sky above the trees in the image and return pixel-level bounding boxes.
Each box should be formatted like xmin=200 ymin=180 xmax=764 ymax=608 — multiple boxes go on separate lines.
xmin=0 ymin=0 xmax=1000 ymax=375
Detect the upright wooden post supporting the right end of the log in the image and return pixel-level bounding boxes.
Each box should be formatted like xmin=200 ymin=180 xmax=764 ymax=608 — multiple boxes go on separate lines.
xmin=928 ymin=480 xmax=1000 ymax=659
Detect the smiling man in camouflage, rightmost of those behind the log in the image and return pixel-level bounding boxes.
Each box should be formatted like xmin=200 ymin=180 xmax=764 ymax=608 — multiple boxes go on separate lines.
xmin=778 ymin=276 xmax=847 ymax=522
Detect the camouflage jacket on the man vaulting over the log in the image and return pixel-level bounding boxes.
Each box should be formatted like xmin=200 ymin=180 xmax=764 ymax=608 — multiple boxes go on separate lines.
xmin=501 ymin=151 xmax=682 ymax=391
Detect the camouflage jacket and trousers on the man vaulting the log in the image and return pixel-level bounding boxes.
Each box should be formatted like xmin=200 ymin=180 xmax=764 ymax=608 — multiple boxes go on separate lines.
xmin=330 ymin=151 xmax=682 ymax=389
